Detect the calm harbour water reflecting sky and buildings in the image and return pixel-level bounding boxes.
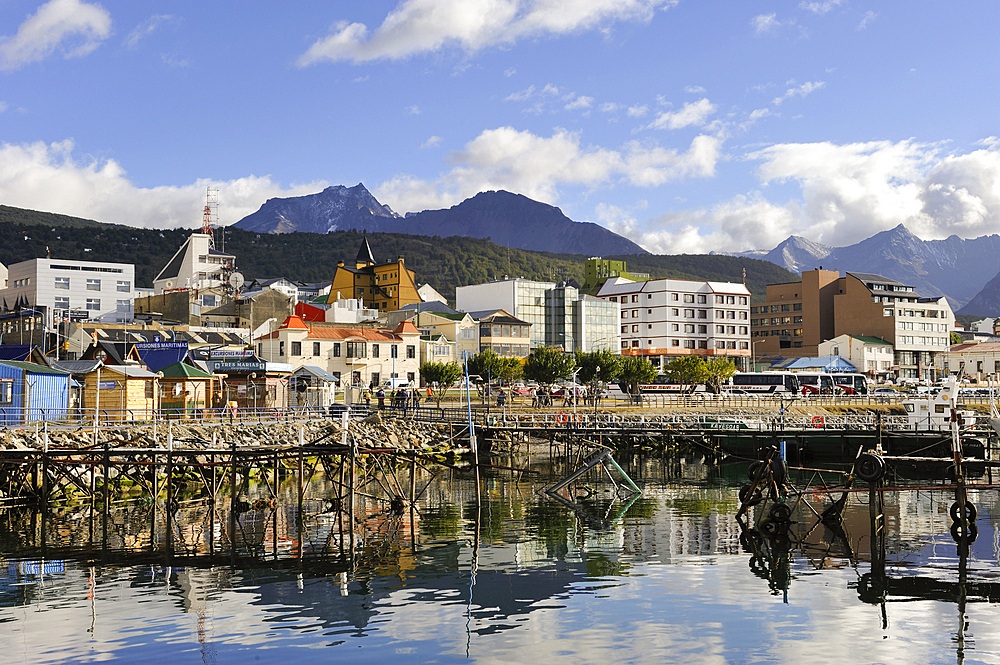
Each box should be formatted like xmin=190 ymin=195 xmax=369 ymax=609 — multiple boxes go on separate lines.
xmin=0 ymin=460 xmax=1000 ymax=663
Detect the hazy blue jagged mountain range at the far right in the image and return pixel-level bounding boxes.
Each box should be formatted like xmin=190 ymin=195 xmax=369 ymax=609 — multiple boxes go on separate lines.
xmin=737 ymin=224 xmax=1000 ymax=316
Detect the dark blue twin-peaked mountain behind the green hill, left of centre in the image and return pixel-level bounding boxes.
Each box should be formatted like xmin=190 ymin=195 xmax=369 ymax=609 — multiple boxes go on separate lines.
xmin=234 ymin=184 xmax=647 ymax=256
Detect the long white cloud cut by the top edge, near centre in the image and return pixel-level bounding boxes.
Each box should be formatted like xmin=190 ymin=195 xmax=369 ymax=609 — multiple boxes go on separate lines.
xmin=299 ymin=0 xmax=678 ymax=67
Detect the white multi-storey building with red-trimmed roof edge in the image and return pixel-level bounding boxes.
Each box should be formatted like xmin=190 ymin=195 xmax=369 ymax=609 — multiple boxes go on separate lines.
xmin=597 ymin=277 xmax=750 ymax=368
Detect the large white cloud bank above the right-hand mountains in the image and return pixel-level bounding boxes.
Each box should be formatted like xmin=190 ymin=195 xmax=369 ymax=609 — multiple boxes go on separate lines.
xmin=624 ymin=141 xmax=1000 ymax=253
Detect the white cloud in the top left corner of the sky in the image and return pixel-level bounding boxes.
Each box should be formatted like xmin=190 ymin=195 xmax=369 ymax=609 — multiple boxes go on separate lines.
xmin=0 ymin=0 xmax=111 ymax=71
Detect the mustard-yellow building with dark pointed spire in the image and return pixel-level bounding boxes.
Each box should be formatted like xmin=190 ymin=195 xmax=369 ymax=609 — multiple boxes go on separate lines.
xmin=327 ymin=238 xmax=422 ymax=312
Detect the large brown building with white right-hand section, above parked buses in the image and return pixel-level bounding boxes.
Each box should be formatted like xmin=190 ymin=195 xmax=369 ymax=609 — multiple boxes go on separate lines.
xmin=750 ymin=268 xmax=955 ymax=379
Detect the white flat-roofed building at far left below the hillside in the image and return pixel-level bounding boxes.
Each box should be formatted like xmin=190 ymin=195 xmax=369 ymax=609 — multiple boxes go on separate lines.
xmin=0 ymin=259 xmax=135 ymax=330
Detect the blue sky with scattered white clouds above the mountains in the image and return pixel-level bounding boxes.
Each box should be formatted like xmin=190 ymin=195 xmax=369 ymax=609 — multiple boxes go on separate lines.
xmin=0 ymin=0 xmax=1000 ymax=253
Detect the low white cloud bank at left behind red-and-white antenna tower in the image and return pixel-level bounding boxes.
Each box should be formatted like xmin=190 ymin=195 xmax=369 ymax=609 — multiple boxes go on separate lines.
xmin=0 ymin=140 xmax=327 ymax=228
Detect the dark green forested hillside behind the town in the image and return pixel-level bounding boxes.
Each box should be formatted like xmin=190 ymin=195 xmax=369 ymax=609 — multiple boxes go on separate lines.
xmin=0 ymin=206 xmax=798 ymax=302
